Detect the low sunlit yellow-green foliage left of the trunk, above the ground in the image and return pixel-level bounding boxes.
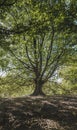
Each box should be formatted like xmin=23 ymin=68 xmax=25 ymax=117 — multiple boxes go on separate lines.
xmin=0 ymin=76 xmax=34 ymax=97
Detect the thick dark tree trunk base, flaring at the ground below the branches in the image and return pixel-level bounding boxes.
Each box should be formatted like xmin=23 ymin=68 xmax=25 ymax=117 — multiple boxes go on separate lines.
xmin=31 ymin=83 xmax=45 ymax=96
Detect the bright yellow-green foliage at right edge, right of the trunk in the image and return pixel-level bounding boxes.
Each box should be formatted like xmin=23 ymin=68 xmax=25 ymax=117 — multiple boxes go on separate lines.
xmin=60 ymin=62 xmax=77 ymax=94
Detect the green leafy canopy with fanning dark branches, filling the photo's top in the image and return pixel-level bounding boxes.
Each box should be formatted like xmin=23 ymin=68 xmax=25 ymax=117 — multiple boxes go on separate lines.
xmin=0 ymin=0 xmax=77 ymax=95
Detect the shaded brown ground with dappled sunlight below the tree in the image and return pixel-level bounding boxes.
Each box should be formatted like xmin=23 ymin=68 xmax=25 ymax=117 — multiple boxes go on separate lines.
xmin=0 ymin=95 xmax=77 ymax=130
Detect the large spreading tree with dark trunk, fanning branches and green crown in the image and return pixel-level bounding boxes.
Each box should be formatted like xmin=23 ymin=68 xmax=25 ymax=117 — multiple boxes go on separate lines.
xmin=2 ymin=0 xmax=77 ymax=95
